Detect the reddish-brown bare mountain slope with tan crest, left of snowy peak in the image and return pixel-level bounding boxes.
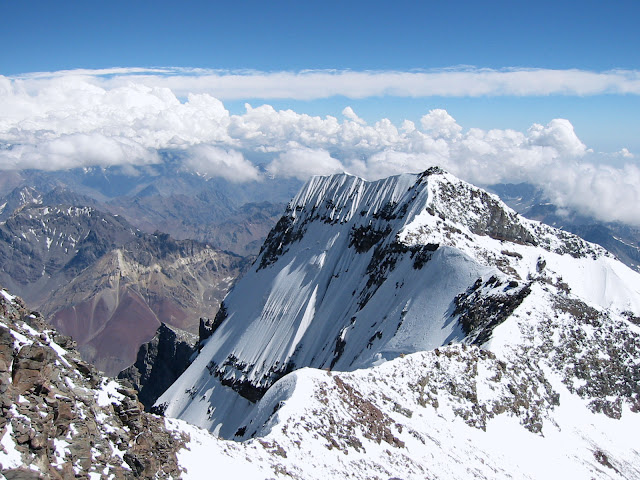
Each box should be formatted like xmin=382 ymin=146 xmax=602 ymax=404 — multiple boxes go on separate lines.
xmin=42 ymin=238 xmax=247 ymax=375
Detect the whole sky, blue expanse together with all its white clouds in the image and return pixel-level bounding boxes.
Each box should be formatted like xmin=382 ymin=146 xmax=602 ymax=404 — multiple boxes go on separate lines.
xmin=0 ymin=0 xmax=640 ymax=224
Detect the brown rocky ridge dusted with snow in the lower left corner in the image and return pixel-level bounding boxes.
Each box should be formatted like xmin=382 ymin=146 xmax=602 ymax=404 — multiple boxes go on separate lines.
xmin=0 ymin=290 xmax=188 ymax=480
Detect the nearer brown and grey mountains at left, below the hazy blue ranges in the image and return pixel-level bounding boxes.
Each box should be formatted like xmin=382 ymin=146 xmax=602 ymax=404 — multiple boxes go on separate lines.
xmin=0 ymin=202 xmax=251 ymax=375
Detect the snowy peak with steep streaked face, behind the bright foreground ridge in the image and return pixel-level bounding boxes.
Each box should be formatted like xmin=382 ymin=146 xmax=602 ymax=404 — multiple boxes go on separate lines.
xmin=157 ymin=168 xmax=640 ymax=444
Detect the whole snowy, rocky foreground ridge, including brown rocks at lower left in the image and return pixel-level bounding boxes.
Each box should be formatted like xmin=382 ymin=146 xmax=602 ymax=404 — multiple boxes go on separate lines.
xmin=0 ymin=276 xmax=640 ymax=480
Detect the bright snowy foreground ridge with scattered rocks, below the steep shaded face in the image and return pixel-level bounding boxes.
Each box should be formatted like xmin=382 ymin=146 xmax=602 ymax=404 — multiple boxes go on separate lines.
xmin=160 ymin=286 xmax=640 ymax=479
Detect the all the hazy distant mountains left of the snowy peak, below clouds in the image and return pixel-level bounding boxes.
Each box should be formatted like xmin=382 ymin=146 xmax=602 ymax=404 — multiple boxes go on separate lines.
xmin=0 ymin=159 xmax=300 ymax=375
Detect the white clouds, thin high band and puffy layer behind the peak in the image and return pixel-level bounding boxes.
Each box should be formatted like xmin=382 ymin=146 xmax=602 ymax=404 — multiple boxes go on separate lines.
xmin=0 ymin=69 xmax=640 ymax=225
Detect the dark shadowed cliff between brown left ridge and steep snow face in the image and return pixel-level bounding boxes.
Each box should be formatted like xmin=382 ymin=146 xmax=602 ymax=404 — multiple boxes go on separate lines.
xmin=118 ymin=323 xmax=198 ymax=411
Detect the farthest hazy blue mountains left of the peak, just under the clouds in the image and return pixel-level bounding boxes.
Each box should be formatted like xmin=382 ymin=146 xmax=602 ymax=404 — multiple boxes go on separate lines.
xmin=0 ymin=158 xmax=300 ymax=256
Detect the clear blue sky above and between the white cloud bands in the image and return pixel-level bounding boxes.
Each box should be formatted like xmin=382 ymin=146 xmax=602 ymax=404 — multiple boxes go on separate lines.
xmin=0 ymin=0 xmax=640 ymax=151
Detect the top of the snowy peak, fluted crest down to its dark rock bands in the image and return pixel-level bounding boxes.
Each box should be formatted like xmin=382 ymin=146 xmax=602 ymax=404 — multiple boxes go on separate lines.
xmin=261 ymin=167 xmax=606 ymax=274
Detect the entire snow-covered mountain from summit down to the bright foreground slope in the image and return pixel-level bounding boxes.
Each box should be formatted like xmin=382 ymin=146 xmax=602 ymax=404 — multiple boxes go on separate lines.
xmin=149 ymin=168 xmax=640 ymax=478
